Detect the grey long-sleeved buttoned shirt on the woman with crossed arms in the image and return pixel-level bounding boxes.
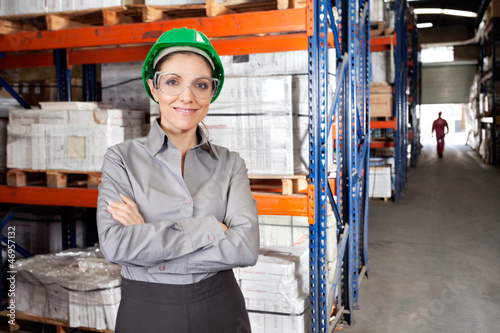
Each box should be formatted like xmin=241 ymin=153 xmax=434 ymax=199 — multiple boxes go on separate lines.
xmin=97 ymin=121 xmax=259 ymax=284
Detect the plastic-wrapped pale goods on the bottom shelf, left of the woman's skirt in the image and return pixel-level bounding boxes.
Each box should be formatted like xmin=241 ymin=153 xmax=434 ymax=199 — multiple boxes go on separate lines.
xmin=15 ymin=249 xmax=121 ymax=330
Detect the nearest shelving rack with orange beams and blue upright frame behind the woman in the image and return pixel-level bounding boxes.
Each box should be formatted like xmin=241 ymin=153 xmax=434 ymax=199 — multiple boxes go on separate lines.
xmin=0 ymin=0 xmax=376 ymax=332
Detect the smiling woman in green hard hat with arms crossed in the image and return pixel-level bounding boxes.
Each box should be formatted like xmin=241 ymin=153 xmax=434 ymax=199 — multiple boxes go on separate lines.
xmin=97 ymin=28 xmax=259 ymax=333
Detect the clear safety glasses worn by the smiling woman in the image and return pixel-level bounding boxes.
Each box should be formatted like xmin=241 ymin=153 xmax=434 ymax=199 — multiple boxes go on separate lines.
xmin=154 ymin=72 xmax=219 ymax=99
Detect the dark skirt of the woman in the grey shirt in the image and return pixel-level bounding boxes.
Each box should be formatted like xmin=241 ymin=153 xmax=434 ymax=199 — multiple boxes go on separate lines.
xmin=115 ymin=270 xmax=251 ymax=333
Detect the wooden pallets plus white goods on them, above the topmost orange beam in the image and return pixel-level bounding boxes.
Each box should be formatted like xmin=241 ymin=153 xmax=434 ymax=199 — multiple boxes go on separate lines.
xmin=0 ymin=0 xmax=306 ymax=34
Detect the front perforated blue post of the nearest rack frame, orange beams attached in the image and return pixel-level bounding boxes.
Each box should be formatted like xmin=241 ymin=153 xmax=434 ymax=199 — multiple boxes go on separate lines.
xmin=308 ymin=0 xmax=330 ymax=332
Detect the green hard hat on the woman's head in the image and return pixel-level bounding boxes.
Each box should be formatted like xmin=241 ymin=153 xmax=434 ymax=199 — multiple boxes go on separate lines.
xmin=142 ymin=28 xmax=224 ymax=103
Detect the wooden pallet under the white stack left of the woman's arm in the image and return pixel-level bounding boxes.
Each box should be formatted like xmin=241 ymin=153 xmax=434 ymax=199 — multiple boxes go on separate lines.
xmin=7 ymin=169 xmax=101 ymax=188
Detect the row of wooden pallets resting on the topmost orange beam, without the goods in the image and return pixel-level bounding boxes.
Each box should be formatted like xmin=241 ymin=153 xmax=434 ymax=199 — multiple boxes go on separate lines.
xmin=0 ymin=0 xmax=306 ymax=35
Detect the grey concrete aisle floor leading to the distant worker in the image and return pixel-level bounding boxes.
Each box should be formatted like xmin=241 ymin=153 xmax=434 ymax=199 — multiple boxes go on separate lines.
xmin=342 ymin=146 xmax=500 ymax=333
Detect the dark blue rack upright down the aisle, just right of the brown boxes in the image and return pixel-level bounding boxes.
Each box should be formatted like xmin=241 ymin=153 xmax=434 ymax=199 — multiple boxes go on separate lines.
xmin=394 ymin=0 xmax=408 ymax=201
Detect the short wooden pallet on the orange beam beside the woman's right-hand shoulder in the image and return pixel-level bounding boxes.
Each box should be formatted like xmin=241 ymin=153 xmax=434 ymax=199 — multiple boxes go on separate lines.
xmin=248 ymin=175 xmax=308 ymax=195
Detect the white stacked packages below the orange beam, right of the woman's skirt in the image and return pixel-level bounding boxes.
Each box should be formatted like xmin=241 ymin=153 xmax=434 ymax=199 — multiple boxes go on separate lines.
xmin=239 ymin=246 xmax=309 ymax=333
